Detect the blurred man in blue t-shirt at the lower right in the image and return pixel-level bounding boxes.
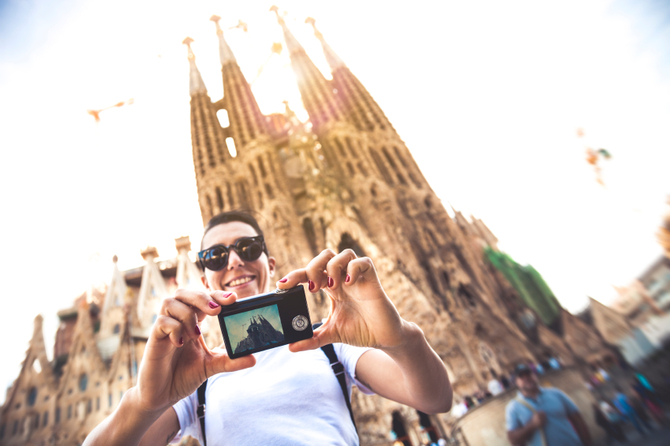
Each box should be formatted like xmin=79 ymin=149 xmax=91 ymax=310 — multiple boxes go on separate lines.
xmin=505 ymin=364 xmax=591 ymax=446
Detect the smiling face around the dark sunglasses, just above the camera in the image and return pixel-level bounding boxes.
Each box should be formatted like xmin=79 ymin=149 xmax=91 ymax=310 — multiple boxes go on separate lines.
xmin=202 ymin=221 xmax=275 ymax=298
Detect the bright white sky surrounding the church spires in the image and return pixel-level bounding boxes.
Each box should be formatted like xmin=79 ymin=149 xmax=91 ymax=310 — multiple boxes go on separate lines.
xmin=0 ymin=0 xmax=670 ymax=400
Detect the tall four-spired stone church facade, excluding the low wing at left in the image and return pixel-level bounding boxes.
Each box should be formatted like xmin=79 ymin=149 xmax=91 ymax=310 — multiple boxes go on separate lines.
xmin=184 ymin=7 xmax=588 ymax=444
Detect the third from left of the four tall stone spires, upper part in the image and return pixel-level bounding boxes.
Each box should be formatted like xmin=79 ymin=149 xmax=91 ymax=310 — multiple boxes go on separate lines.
xmin=270 ymin=6 xmax=343 ymax=133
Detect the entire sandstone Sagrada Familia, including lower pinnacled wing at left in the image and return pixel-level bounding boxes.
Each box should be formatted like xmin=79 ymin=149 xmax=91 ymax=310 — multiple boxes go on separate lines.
xmin=0 ymin=9 xmax=616 ymax=446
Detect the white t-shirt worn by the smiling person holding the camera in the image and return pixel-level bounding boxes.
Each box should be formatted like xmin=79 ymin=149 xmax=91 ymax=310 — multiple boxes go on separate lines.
xmin=172 ymin=344 xmax=373 ymax=446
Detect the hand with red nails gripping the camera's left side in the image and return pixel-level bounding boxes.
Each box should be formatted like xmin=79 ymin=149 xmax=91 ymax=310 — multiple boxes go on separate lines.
xmin=137 ymin=289 xmax=256 ymax=411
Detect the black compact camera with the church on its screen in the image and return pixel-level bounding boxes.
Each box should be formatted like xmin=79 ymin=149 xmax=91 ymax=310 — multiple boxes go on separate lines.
xmin=219 ymin=285 xmax=314 ymax=359
